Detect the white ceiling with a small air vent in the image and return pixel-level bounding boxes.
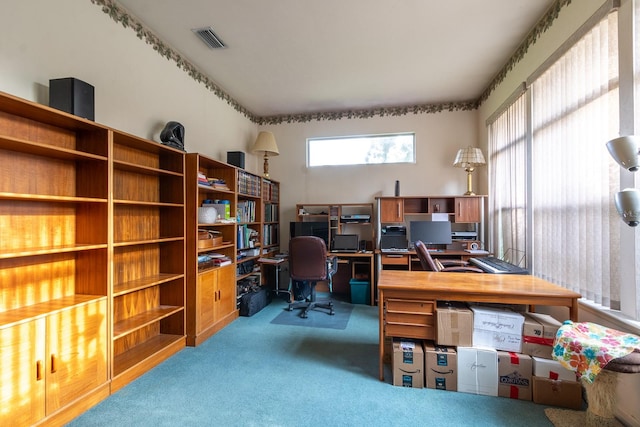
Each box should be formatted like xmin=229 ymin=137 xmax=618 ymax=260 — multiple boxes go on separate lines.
xmin=112 ymin=0 xmax=554 ymax=116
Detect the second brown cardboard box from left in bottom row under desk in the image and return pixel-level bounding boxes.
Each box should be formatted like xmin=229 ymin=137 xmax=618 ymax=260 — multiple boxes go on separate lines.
xmin=424 ymin=341 xmax=458 ymax=391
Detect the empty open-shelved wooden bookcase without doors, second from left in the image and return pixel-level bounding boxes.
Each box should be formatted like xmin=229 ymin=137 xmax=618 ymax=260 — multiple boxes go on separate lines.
xmin=111 ymin=131 xmax=185 ymax=391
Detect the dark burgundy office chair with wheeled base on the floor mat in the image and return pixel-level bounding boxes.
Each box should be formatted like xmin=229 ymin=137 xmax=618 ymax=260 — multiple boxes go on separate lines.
xmin=288 ymin=236 xmax=338 ymax=318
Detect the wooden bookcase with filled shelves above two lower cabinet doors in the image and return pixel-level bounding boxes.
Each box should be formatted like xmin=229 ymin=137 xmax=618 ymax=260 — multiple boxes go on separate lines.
xmin=186 ymin=153 xmax=238 ymax=346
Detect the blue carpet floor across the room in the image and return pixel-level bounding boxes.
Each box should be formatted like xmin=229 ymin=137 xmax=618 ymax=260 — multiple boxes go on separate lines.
xmin=69 ymin=298 xmax=552 ymax=427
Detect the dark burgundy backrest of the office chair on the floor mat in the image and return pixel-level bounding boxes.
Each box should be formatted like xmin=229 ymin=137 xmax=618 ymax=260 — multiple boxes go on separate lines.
xmin=289 ymin=236 xmax=327 ymax=281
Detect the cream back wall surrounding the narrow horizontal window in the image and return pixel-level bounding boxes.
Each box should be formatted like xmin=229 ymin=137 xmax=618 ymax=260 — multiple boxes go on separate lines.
xmin=264 ymin=111 xmax=477 ymax=236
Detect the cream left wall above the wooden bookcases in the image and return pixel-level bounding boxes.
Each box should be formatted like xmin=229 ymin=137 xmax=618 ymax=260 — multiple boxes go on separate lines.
xmin=0 ymin=0 xmax=262 ymax=172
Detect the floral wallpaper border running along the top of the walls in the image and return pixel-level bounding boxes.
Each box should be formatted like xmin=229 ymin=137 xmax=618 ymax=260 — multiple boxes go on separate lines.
xmin=91 ymin=0 xmax=572 ymax=125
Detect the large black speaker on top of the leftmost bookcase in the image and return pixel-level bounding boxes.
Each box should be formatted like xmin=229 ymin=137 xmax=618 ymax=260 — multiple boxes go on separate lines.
xmin=49 ymin=77 xmax=95 ymax=120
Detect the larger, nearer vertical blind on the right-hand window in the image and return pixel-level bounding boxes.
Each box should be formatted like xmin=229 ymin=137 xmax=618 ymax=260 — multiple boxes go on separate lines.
xmin=531 ymin=13 xmax=620 ymax=309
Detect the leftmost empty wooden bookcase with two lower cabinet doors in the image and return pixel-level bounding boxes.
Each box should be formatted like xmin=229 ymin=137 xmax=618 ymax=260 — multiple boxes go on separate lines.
xmin=0 ymin=94 xmax=111 ymax=425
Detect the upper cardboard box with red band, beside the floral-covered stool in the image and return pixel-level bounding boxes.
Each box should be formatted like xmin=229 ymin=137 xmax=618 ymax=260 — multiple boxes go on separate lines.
xmin=522 ymin=313 xmax=562 ymax=359
